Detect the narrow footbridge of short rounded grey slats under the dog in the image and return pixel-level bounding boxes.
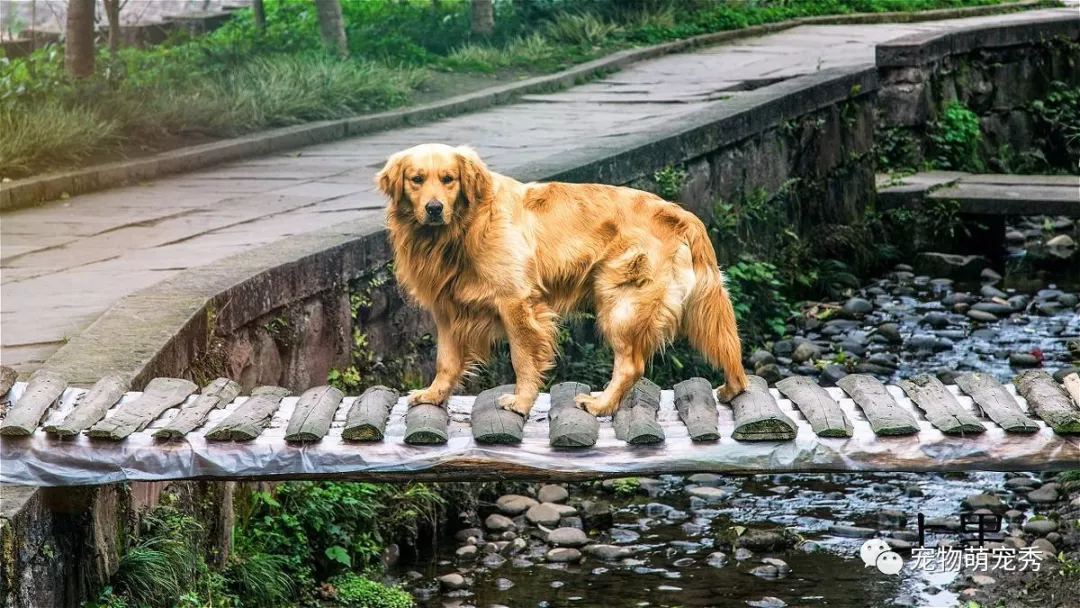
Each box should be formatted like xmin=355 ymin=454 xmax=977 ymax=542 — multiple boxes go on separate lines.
xmin=0 ymin=369 xmax=1080 ymax=486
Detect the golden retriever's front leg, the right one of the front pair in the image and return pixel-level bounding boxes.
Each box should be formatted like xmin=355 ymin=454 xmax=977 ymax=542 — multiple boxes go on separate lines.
xmin=499 ymin=300 xmax=558 ymax=416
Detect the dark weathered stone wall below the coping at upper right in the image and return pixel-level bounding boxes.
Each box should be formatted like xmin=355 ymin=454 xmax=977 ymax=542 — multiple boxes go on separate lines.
xmin=877 ymin=14 xmax=1080 ymax=171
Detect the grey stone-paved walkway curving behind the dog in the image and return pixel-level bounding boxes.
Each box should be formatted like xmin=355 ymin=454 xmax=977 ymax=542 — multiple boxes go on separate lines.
xmin=0 ymin=9 xmax=1063 ymax=371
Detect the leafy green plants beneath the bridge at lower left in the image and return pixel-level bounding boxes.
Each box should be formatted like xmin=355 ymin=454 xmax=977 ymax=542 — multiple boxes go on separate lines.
xmin=87 ymin=482 xmax=444 ymax=608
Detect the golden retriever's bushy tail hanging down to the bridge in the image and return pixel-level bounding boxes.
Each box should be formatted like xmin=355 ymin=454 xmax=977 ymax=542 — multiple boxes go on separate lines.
xmin=683 ymin=218 xmax=750 ymax=401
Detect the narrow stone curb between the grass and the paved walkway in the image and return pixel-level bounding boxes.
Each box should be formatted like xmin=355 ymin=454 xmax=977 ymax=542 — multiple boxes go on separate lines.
xmin=0 ymin=0 xmax=1043 ymax=211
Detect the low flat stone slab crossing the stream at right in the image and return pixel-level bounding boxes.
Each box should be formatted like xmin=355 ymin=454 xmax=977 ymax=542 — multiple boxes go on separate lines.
xmin=878 ymin=171 xmax=1080 ymax=217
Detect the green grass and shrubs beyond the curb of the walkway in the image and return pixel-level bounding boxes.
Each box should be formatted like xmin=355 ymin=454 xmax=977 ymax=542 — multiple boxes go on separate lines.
xmin=0 ymin=0 xmax=1005 ymax=178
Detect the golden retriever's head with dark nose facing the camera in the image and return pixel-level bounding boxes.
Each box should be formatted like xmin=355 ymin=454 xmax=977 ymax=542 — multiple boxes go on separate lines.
xmin=375 ymin=144 xmax=491 ymax=226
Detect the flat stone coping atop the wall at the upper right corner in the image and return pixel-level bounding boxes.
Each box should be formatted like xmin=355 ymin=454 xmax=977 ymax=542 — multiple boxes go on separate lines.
xmin=876 ymin=9 xmax=1080 ymax=68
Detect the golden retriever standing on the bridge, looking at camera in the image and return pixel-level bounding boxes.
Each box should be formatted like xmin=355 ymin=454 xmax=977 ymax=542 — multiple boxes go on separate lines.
xmin=376 ymin=144 xmax=747 ymax=416
